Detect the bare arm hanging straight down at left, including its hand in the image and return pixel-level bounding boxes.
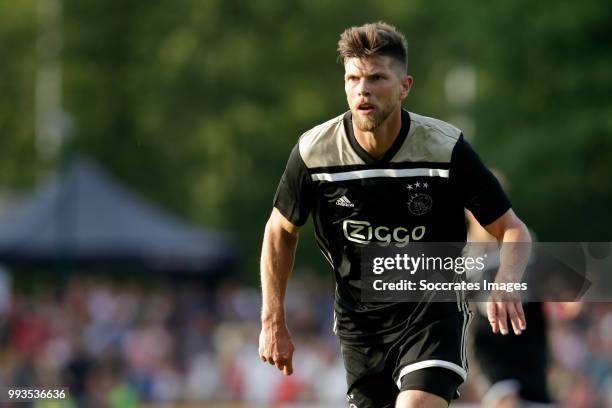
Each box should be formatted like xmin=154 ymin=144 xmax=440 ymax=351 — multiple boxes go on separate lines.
xmin=259 ymin=208 xmax=299 ymax=375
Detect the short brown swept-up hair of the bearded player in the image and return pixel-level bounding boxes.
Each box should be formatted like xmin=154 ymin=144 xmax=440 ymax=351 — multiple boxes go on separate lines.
xmin=338 ymin=21 xmax=408 ymax=72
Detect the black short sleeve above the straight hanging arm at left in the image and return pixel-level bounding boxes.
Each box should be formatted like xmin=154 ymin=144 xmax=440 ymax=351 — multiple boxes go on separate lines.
xmin=274 ymin=144 xmax=314 ymax=226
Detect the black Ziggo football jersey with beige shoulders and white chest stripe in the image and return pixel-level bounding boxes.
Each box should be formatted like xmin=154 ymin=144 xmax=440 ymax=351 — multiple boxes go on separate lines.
xmin=274 ymin=110 xmax=510 ymax=337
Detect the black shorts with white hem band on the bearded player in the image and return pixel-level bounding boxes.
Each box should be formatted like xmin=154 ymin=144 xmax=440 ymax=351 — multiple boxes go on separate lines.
xmin=341 ymin=305 xmax=472 ymax=408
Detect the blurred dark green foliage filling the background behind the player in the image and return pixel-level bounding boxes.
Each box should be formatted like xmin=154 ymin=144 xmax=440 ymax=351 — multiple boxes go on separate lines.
xmin=0 ymin=0 xmax=612 ymax=282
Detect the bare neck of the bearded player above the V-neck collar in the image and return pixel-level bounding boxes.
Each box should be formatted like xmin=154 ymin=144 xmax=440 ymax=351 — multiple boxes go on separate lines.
xmin=353 ymin=105 xmax=402 ymax=159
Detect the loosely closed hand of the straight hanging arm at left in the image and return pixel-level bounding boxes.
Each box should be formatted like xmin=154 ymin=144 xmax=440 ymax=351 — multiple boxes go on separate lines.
xmin=259 ymin=323 xmax=294 ymax=375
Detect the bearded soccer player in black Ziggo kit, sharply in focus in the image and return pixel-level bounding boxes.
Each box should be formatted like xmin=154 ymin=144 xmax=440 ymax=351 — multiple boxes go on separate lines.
xmin=259 ymin=22 xmax=529 ymax=408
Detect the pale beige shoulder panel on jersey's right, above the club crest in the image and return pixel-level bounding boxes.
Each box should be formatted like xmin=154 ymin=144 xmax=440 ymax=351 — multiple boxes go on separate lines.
xmin=391 ymin=112 xmax=461 ymax=163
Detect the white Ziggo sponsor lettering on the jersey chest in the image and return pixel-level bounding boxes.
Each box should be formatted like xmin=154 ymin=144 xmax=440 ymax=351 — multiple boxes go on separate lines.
xmin=342 ymin=220 xmax=425 ymax=248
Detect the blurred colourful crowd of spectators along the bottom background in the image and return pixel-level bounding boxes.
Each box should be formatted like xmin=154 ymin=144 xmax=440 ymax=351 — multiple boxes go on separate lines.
xmin=0 ymin=271 xmax=612 ymax=408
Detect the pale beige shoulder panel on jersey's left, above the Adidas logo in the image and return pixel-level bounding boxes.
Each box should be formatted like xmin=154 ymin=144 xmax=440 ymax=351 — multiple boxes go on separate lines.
xmin=299 ymin=114 xmax=364 ymax=168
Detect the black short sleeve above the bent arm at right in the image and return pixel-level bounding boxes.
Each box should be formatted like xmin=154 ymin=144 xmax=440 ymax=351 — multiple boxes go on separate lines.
xmin=450 ymin=135 xmax=511 ymax=226
